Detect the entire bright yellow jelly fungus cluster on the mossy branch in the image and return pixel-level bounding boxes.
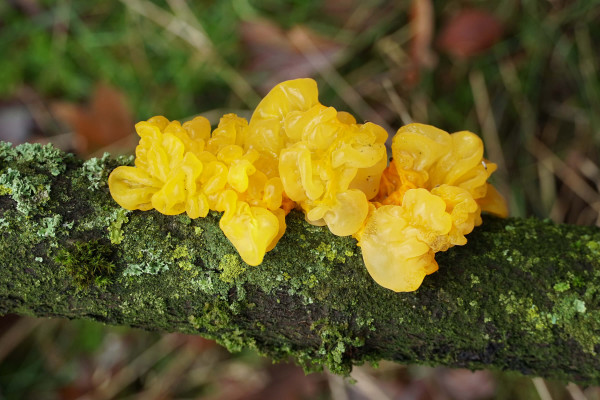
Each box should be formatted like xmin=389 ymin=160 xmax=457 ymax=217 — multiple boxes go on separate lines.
xmin=108 ymin=79 xmax=507 ymax=291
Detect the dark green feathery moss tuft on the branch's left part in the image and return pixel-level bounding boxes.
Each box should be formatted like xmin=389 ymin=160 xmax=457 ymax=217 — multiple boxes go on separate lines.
xmin=54 ymin=240 xmax=115 ymax=289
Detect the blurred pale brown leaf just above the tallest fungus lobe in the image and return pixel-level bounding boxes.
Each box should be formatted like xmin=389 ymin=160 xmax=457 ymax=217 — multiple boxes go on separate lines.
xmin=240 ymin=20 xmax=342 ymax=90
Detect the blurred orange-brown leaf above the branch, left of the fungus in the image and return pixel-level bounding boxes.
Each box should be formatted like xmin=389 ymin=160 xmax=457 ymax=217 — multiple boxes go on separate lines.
xmin=52 ymin=84 xmax=133 ymax=156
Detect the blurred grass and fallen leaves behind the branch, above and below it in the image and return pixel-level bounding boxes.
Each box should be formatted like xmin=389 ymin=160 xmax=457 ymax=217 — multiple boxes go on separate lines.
xmin=0 ymin=0 xmax=600 ymax=400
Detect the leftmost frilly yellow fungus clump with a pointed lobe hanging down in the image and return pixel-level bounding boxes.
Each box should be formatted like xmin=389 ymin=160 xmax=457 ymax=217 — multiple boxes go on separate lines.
xmin=109 ymin=114 xmax=291 ymax=265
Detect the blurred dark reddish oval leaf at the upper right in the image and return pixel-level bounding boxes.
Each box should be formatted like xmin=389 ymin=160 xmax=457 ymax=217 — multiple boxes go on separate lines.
xmin=437 ymin=9 xmax=503 ymax=58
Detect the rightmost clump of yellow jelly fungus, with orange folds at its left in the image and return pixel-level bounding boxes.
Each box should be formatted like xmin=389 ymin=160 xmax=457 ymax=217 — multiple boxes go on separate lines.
xmin=355 ymin=124 xmax=508 ymax=292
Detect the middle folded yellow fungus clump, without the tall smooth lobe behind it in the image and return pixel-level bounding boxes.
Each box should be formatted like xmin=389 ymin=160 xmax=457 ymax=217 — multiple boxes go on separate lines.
xmin=279 ymin=97 xmax=387 ymax=236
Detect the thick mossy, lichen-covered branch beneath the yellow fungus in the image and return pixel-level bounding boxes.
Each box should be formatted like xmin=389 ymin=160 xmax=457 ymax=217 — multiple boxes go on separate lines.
xmin=0 ymin=143 xmax=600 ymax=384
